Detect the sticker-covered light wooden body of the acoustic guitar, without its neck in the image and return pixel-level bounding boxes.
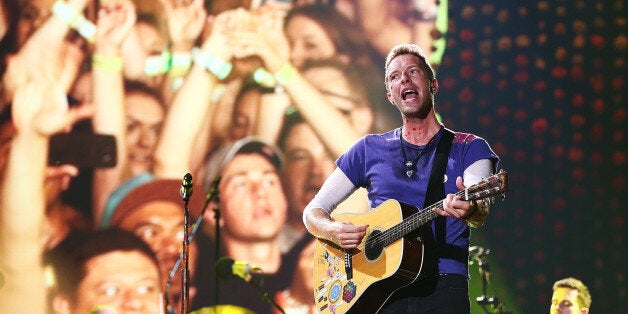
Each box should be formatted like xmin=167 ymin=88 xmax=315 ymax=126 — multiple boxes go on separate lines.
xmin=313 ymin=200 xmax=423 ymax=313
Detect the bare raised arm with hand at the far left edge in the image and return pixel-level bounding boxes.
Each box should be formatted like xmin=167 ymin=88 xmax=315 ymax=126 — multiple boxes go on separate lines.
xmin=0 ymin=71 xmax=72 ymax=313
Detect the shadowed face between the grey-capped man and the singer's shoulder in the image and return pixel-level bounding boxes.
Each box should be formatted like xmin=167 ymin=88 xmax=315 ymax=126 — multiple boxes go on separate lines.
xmin=283 ymin=122 xmax=336 ymax=220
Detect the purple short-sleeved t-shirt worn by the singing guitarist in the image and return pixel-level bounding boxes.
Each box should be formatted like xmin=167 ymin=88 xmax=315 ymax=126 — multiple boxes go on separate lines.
xmin=336 ymin=127 xmax=499 ymax=276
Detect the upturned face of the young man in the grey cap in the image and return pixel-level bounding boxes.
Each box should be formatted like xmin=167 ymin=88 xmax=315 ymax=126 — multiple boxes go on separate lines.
xmin=220 ymin=153 xmax=288 ymax=242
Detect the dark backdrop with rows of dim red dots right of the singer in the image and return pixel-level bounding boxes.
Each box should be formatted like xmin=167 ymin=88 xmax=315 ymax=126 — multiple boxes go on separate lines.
xmin=436 ymin=0 xmax=628 ymax=313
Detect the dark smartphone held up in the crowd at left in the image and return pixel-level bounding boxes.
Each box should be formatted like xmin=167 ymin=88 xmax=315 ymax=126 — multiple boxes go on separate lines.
xmin=48 ymin=133 xmax=117 ymax=168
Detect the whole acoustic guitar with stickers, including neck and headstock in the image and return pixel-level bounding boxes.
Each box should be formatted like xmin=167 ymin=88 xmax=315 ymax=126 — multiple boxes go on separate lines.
xmin=313 ymin=171 xmax=508 ymax=313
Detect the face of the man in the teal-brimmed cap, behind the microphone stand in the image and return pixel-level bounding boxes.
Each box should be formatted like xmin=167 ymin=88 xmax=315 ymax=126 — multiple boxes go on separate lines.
xmin=120 ymin=201 xmax=198 ymax=287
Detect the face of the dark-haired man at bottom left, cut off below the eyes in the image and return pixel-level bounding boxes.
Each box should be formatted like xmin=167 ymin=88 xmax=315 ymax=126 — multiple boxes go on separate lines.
xmin=72 ymin=251 xmax=161 ymax=314
